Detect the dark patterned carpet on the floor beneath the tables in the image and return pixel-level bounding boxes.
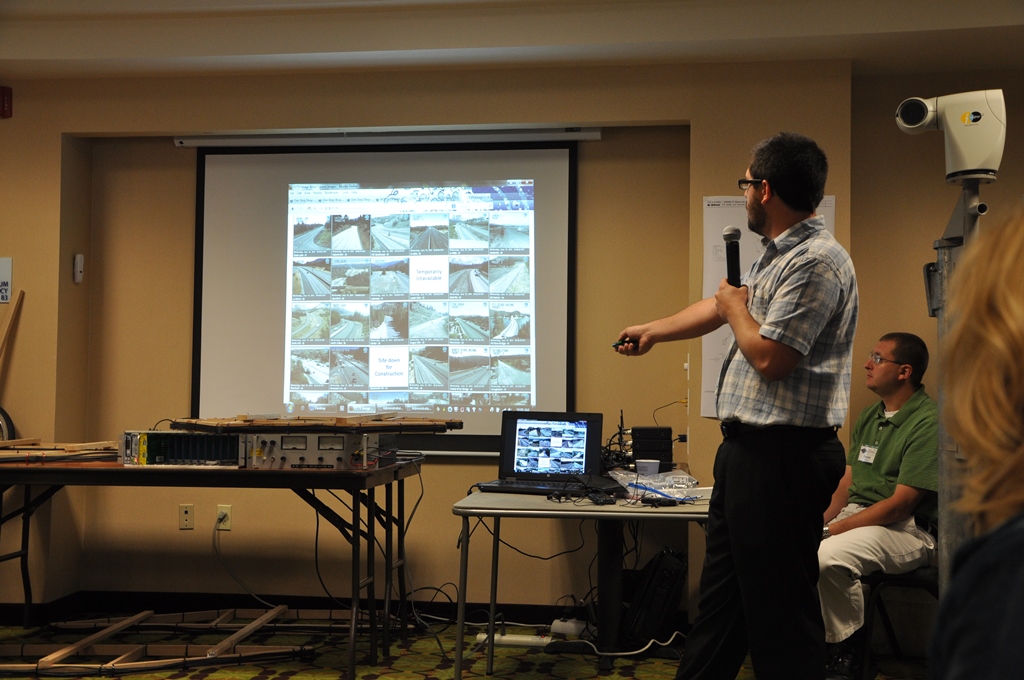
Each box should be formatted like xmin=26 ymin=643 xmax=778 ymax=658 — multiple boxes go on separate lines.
xmin=0 ymin=623 xmax=927 ymax=680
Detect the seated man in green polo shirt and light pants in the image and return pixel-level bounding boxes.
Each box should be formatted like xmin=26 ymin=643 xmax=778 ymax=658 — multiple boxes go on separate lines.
xmin=818 ymin=333 xmax=938 ymax=680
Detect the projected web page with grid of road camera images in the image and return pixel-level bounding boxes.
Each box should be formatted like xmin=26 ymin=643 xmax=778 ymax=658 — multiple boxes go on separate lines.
xmin=285 ymin=180 xmax=536 ymax=417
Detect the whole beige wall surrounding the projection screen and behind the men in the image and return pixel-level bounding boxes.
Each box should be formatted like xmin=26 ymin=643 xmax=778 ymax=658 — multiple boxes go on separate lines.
xmin=9 ymin=62 xmax=1024 ymax=604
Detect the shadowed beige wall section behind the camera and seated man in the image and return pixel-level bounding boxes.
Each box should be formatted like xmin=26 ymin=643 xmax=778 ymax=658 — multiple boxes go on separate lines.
xmin=851 ymin=72 xmax=1024 ymax=413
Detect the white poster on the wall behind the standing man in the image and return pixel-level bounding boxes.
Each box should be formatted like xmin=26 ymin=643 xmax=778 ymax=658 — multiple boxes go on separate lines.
xmin=700 ymin=196 xmax=836 ymax=418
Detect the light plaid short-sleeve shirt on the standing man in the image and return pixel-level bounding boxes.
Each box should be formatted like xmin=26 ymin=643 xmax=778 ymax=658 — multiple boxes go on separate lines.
xmin=717 ymin=216 xmax=859 ymax=427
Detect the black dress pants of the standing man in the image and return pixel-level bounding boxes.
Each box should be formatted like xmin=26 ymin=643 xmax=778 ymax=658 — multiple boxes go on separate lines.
xmin=677 ymin=424 xmax=846 ymax=680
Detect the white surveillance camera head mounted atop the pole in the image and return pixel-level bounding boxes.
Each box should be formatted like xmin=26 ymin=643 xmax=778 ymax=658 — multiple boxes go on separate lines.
xmin=896 ymin=90 xmax=1007 ymax=184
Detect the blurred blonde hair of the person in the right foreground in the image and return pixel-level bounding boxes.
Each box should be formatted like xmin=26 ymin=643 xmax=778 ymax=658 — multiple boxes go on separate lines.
xmin=943 ymin=210 xmax=1024 ymax=530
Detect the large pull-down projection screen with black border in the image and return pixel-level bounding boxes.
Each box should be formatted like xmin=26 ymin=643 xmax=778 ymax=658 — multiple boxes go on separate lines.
xmin=193 ymin=142 xmax=575 ymax=435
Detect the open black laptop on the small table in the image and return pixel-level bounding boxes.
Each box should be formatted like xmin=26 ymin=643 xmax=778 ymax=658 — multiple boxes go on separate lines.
xmin=476 ymin=411 xmax=622 ymax=495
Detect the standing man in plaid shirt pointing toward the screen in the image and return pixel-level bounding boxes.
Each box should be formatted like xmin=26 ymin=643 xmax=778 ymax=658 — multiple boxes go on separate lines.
xmin=616 ymin=132 xmax=858 ymax=680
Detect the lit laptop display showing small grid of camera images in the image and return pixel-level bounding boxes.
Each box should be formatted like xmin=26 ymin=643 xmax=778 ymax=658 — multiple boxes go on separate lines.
xmin=515 ymin=420 xmax=587 ymax=474
